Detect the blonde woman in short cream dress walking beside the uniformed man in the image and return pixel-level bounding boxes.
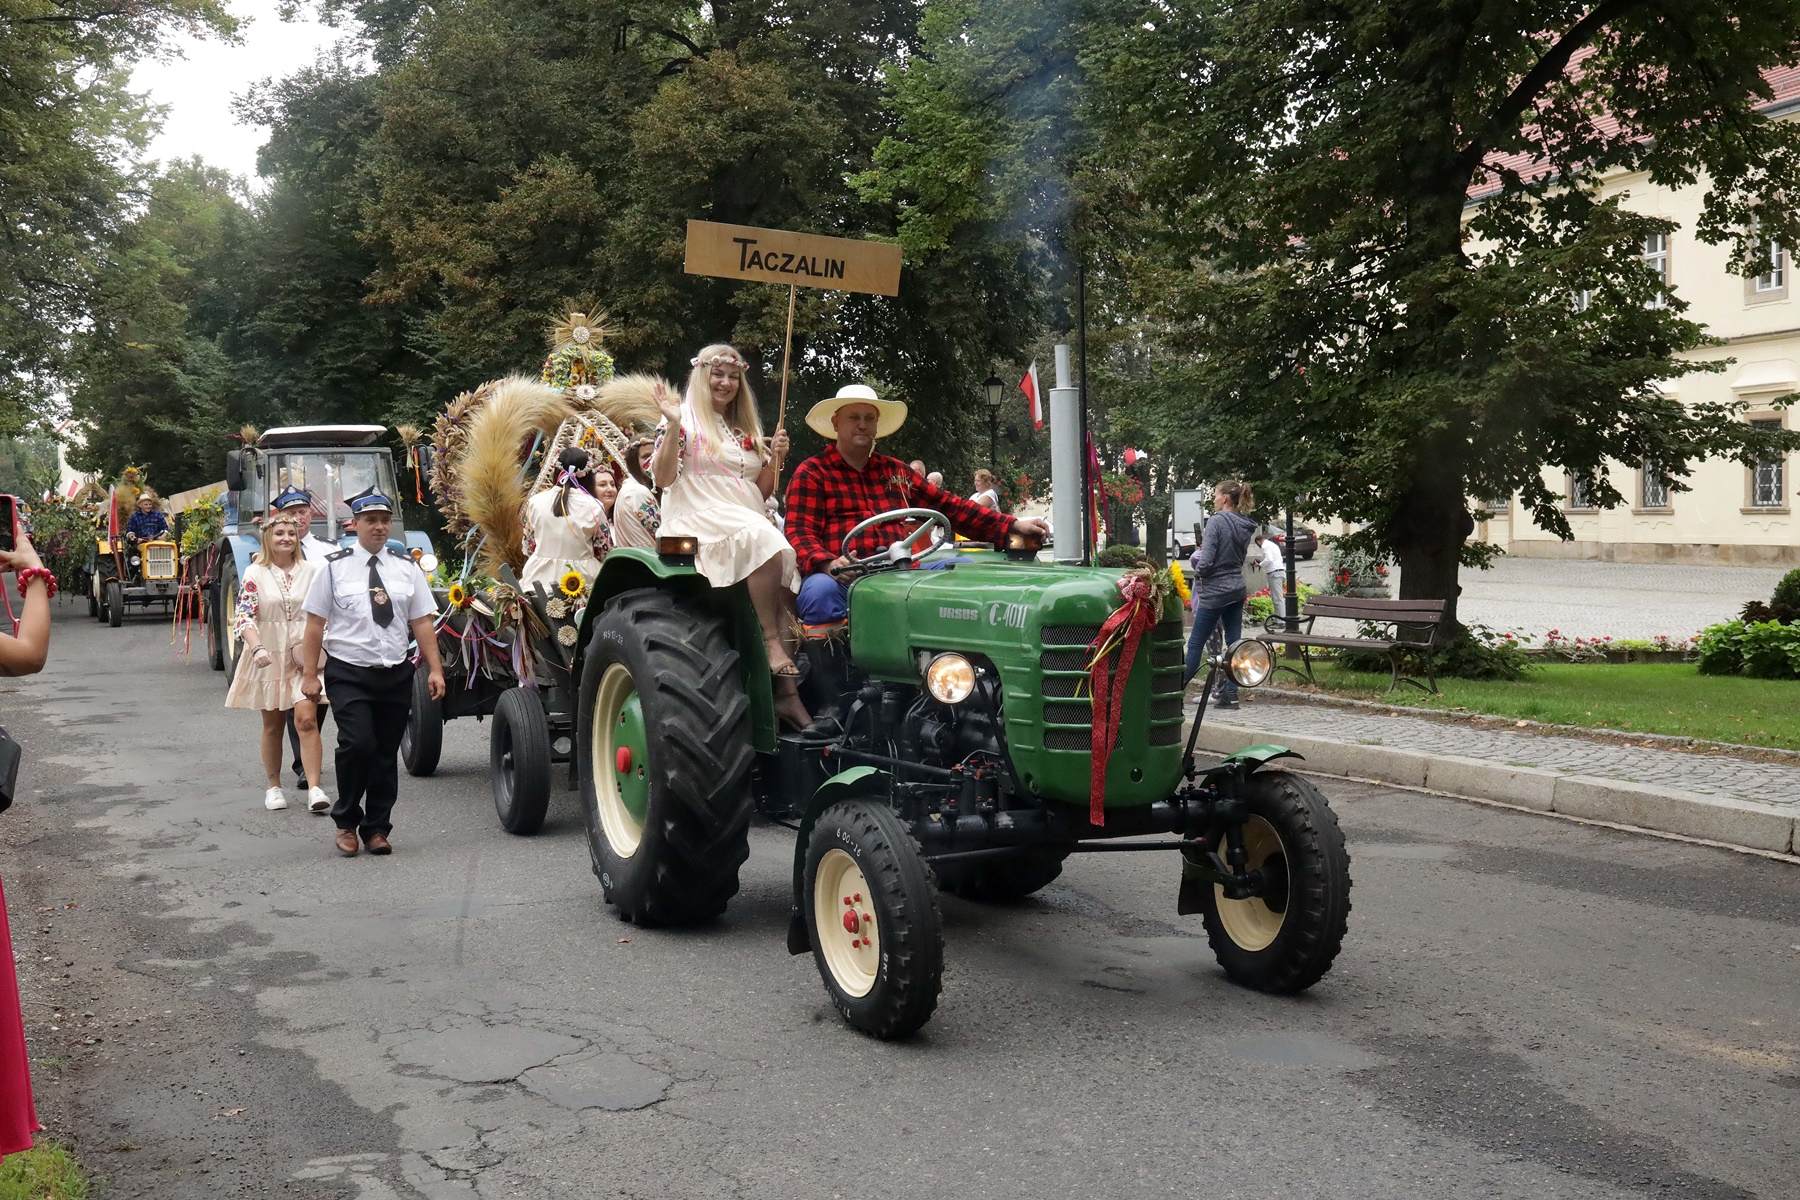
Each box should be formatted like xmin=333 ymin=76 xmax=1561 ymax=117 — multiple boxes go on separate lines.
xmin=225 ymin=513 xmax=331 ymax=813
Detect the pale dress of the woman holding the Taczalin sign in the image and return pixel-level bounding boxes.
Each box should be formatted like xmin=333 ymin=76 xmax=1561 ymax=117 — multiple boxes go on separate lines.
xmin=657 ymin=405 xmax=799 ymax=592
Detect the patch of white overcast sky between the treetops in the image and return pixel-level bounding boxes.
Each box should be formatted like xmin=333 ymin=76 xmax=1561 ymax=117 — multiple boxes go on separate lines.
xmin=131 ymin=0 xmax=342 ymax=185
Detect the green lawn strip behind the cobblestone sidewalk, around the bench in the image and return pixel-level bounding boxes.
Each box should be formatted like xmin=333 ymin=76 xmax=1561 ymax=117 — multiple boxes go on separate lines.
xmin=1303 ymin=662 xmax=1800 ymax=750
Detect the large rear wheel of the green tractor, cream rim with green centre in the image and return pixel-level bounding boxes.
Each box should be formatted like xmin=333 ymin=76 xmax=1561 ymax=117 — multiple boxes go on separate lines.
xmin=576 ymin=588 xmax=754 ymax=925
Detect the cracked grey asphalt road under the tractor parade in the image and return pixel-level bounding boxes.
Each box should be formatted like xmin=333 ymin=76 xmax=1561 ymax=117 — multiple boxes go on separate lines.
xmin=0 ymin=606 xmax=1800 ymax=1200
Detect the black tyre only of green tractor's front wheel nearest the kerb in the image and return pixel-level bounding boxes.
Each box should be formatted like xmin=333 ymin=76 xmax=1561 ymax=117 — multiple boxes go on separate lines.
xmin=1201 ymin=770 xmax=1350 ymax=995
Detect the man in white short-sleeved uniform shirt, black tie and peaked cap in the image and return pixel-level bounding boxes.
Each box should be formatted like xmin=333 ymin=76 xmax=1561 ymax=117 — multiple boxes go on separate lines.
xmin=301 ymin=488 xmax=445 ymax=858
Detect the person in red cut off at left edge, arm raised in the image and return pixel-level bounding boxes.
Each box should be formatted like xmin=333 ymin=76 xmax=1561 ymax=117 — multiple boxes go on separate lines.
xmin=0 ymin=529 xmax=56 ymax=1159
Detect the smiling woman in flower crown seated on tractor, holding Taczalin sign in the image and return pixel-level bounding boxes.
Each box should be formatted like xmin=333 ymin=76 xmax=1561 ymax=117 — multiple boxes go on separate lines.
xmin=650 ymin=344 xmax=812 ymax=727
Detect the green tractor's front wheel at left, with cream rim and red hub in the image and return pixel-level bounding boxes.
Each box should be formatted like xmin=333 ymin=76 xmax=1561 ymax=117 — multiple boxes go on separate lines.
xmin=806 ymin=801 xmax=943 ymax=1038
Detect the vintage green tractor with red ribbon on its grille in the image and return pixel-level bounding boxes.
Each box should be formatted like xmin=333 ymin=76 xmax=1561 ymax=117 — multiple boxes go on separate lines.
xmin=574 ymin=509 xmax=1350 ymax=1038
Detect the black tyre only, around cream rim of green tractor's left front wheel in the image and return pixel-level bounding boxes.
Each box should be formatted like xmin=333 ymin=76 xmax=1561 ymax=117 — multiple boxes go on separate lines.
xmin=805 ymin=801 xmax=943 ymax=1042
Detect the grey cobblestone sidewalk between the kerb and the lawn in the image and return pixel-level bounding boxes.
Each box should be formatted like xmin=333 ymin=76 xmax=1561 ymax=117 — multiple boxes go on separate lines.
xmin=1206 ymin=700 xmax=1800 ymax=811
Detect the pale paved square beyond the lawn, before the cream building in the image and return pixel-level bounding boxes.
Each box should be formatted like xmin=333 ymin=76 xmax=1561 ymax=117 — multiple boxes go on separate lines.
xmin=1288 ymin=554 xmax=1786 ymax=637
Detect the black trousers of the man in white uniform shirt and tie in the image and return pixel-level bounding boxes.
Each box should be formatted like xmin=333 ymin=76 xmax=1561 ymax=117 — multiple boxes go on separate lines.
xmin=324 ymin=658 xmax=412 ymax=837
